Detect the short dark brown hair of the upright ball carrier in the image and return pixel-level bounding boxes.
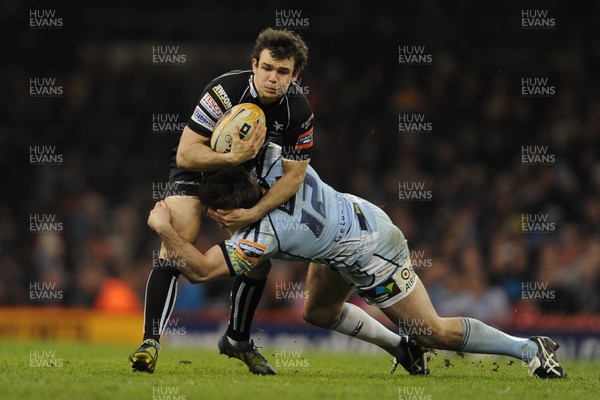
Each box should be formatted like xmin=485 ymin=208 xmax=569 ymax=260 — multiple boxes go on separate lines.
xmin=250 ymin=28 xmax=308 ymax=74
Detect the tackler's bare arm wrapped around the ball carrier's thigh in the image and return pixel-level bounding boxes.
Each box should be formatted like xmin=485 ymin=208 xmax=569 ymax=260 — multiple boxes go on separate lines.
xmin=148 ymin=201 xmax=230 ymax=283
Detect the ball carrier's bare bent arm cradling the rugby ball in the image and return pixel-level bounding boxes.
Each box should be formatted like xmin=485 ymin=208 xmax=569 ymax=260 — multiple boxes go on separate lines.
xmin=177 ymin=125 xmax=267 ymax=172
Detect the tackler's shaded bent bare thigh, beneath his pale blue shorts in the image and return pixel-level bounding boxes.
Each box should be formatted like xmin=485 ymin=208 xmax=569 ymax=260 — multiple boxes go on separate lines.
xmin=304 ymin=263 xmax=353 ymax=312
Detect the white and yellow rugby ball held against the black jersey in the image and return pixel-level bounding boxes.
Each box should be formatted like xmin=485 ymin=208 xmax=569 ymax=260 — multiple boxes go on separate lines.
xmin=210 ymin=103 xmax=266 ymax=153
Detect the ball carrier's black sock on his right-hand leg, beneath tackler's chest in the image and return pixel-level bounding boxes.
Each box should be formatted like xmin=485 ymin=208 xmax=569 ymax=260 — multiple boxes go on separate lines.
xmin=227 ymin=274 xmax=267 ymax=342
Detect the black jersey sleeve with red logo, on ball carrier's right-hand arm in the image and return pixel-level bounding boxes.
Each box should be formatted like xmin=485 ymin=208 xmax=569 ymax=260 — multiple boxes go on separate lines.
xmin=281 ymin=97 xmax=314 ymax=161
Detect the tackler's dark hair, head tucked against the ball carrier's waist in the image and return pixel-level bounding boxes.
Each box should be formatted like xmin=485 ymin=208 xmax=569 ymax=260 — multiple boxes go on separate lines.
xmin=198 ymin=165 xmax=262 ymax=210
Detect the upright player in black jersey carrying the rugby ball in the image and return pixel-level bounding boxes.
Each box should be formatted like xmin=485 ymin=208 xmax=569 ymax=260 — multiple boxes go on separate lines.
xmin=129 ymin=28 xmax=313 ymax=374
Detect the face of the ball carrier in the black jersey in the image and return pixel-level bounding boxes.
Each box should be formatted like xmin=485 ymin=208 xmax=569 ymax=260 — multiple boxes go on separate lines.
xmin=252 ymin=49 xmax=298 ymax=104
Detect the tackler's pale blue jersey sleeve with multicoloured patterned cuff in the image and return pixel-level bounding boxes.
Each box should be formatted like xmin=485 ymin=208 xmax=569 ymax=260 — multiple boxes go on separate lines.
xmin=221 ymin=219 xmax=278 ymax=276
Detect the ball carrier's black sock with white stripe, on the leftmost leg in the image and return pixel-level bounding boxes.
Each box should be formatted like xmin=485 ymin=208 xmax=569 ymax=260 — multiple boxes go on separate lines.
xmin=144 ymin=259 xmax=180 ymax=342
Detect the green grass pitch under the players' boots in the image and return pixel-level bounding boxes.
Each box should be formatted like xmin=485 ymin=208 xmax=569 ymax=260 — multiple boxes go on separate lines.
xmin=0 ymin=341 xmax=600 ymax=400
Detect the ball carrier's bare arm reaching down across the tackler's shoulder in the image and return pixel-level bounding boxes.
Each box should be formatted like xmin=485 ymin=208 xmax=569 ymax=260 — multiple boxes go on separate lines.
xmin=208 ymin=159 xmax=309 ymax=231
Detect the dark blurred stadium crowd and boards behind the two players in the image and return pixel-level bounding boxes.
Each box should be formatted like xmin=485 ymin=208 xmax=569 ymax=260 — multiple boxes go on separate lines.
xmin=0 ymin=0 xmax=600 ymax=358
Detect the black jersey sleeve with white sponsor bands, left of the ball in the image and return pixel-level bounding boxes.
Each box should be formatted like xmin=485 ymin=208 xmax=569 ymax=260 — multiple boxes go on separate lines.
xmin=188 ymin=74 xmax=237 ymax=138
